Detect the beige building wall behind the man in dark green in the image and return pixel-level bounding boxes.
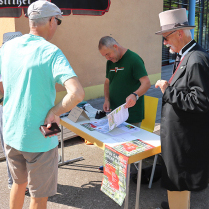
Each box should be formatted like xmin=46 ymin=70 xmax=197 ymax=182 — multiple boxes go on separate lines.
xmin=4 ymin=0 xmax=163 ymax=99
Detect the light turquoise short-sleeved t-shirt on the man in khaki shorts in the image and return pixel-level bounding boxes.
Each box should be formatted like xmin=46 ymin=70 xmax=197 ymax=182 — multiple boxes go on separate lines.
xmin=0 ymin=34 xmax=76 ymax=152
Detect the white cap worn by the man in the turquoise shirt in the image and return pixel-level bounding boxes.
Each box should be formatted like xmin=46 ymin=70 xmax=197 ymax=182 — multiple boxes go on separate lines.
xmin=27 ymin=0 xmax=62 ymax=20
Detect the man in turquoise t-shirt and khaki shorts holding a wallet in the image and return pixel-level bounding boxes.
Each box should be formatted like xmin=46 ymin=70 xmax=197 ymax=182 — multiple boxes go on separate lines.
xmin=0 ymin=1 xmax=84 ymax=209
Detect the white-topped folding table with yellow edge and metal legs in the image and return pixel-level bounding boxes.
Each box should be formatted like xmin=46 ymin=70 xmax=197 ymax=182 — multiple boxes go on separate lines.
xmin=60 ymin=116 xmax=161 ymax=209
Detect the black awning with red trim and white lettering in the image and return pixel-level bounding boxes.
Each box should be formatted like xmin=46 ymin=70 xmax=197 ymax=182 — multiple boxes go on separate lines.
xmin=0 ymin=0 xmax=110 ymax=17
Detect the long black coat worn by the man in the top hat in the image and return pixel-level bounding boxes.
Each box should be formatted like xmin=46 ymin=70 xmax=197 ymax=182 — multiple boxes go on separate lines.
xmin=160 ymin=44 xmax=209 ymax=191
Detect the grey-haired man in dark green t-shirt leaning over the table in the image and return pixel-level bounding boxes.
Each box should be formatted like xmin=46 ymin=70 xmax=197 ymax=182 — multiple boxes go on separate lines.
xmin=99 ymin=36 xmax=150 ymax=126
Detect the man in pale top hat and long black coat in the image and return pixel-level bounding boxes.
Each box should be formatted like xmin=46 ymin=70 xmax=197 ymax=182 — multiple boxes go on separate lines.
xmin=155 ymin=8 xmax=209 ymax=209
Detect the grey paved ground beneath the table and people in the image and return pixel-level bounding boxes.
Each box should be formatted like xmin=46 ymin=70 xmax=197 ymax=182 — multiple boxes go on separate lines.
xmin=0 ymin=137 xmax=209 ymax=209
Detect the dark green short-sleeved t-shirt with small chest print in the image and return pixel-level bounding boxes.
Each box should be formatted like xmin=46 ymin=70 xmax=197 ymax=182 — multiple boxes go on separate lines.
xmin=106 ymin=50 xmax=147 ymax=123
